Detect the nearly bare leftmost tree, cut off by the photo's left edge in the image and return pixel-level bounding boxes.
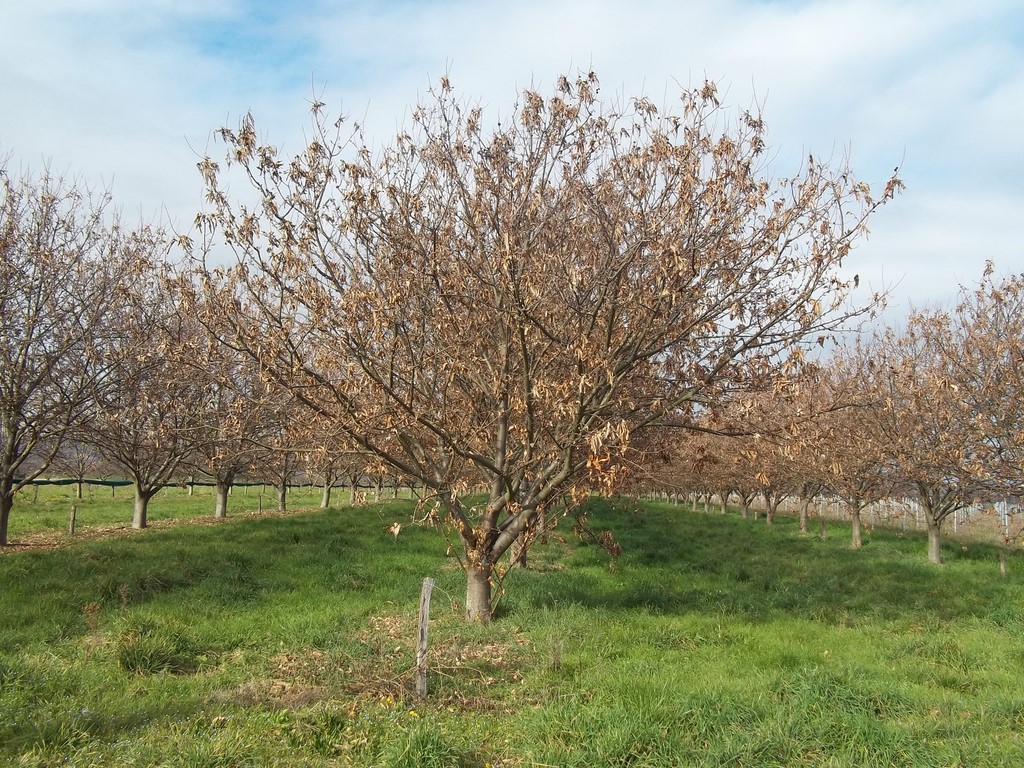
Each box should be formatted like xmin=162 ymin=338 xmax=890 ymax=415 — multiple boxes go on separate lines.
xmin=0 ymin=163 xmax=119 ymax=546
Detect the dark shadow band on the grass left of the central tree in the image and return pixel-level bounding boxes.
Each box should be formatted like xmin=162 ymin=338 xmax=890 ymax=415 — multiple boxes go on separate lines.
xmin=0 ymin=505 xmax=452 ymax=651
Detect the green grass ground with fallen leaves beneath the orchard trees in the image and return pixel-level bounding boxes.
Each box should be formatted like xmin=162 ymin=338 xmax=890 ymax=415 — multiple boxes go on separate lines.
xmin=0 ymin=490 xmax=1024 ymax=768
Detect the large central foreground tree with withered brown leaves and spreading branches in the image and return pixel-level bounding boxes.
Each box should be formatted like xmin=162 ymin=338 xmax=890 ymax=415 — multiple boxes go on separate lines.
xmin=190 ymin=74 xmax=899 ymax=622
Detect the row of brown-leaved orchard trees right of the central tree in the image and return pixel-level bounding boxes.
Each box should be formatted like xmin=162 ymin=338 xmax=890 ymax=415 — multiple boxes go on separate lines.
xmin=634 ymin=265 xmax=1024 ymax=563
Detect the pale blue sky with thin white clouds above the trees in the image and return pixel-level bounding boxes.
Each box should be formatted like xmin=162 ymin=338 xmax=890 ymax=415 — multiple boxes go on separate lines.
xmin=0 ymin=0 xmax=1024 ymax=313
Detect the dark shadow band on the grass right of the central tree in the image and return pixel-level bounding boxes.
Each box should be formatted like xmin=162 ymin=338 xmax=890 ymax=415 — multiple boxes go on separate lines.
xmin=511 ymin=501 xmax=1021 ymax=626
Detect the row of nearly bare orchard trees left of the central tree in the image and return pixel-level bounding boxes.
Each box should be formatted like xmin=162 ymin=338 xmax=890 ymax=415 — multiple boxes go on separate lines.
xmin=0 ymin=168 xmax=387 ymax=546
